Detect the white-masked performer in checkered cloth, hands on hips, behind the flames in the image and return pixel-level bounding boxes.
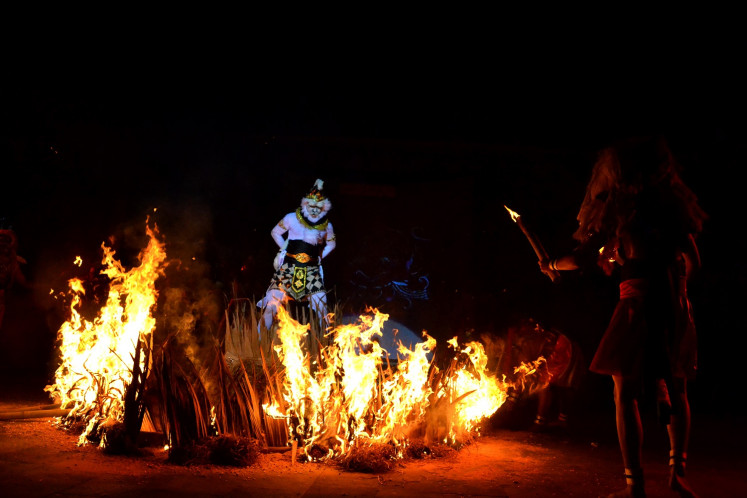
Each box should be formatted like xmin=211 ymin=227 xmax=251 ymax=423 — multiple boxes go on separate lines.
xmin=258 ymin=179 xmax=336 ymax=330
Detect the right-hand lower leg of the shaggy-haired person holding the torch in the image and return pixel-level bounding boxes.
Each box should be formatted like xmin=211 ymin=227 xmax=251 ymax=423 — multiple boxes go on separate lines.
xmin=667 ymin=379 xmax=697 ymax=497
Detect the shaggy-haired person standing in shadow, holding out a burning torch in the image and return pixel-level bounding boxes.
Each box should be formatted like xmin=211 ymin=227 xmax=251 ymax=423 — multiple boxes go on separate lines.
xmin=540 ymin=134 xmax=706 ymax=496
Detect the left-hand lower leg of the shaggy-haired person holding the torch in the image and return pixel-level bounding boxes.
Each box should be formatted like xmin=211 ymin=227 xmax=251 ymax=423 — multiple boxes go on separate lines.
xmin=610 ymin=375 xmax=646 ymax=497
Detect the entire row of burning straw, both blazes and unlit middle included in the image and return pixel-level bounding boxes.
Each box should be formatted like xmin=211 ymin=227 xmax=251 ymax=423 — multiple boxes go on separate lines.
xmin=46 ymin=221 xmax=556 ymax=472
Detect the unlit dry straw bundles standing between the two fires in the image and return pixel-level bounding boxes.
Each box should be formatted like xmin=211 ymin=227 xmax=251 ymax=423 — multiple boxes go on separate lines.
xmin=148 ymin=294 xmax=300 ymax=463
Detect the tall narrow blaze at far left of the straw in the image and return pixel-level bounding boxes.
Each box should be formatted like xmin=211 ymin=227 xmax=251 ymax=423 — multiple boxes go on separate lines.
xmin=45 ymin=221 xmax=166 ymax=444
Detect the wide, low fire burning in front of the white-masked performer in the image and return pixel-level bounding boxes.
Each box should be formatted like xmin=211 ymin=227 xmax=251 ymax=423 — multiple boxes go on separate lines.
xmin=265 ymin=307 xmax=544 ymax=460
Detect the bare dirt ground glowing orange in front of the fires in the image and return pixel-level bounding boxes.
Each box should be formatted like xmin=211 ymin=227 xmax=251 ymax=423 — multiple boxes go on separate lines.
xmin=0 ymin=372 xmax=747 ymax=498
